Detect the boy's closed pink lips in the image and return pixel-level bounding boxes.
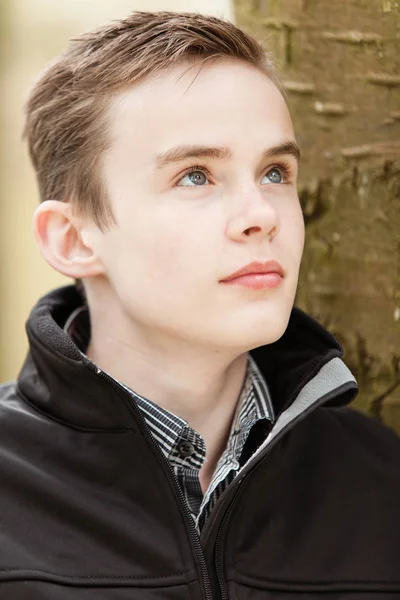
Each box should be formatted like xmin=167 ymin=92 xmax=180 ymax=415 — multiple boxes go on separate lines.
xmin=220 ymin=260 xmax=285 ymax=290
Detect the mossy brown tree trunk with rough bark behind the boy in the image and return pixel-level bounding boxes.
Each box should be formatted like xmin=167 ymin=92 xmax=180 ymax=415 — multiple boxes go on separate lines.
xmin=235 ymin=0 xmax=400 ymax=432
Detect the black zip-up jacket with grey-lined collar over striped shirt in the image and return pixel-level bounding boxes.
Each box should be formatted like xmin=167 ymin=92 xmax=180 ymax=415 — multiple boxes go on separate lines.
xmin=0 ymin=287 xmax=400 ymax=600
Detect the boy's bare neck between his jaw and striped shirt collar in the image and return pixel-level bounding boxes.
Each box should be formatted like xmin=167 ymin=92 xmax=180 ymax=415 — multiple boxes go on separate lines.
xmin=87 ymin=296 xmax=247 ymax=489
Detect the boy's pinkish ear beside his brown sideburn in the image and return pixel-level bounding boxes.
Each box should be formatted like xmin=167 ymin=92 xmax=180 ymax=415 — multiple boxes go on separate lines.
xmin=33 ymin=200 xmax=104 ymax=279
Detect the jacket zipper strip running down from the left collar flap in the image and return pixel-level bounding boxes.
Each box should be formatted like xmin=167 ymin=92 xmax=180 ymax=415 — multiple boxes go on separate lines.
xmin=88 ymin=363 xmax=213 ymax=600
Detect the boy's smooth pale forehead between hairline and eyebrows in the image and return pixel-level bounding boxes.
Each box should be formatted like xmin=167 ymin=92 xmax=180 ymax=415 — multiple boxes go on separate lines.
xmin=108 ymin=60 xmax=294 ymax=152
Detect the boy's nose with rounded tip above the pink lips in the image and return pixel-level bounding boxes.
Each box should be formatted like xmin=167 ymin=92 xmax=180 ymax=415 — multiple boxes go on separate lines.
xmin=226 ymin=189 xmax=280 ymax=242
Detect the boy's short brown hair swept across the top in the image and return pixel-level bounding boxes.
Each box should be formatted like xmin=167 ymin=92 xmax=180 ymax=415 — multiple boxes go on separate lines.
xmin=24 ymin=11 xmax=279 ymax=228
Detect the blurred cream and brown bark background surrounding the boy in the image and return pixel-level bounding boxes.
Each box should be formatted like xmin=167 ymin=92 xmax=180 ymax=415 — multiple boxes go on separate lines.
xmin=0 ymin=0 xmax=400 ymax=432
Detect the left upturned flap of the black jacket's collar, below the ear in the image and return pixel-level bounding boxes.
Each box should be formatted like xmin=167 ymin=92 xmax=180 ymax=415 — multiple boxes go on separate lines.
xmin=17 ymin=286 xmax=137 ymax=431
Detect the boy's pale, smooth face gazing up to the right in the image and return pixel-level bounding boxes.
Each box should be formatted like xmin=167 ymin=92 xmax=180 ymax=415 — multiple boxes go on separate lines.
xmin=88 ymin=61 xmax=304 ymax=351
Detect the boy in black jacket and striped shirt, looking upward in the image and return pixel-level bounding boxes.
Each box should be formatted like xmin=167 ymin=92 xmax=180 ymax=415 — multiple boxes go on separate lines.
xmin=0 ymin=13 xmax=400 ymax=600
